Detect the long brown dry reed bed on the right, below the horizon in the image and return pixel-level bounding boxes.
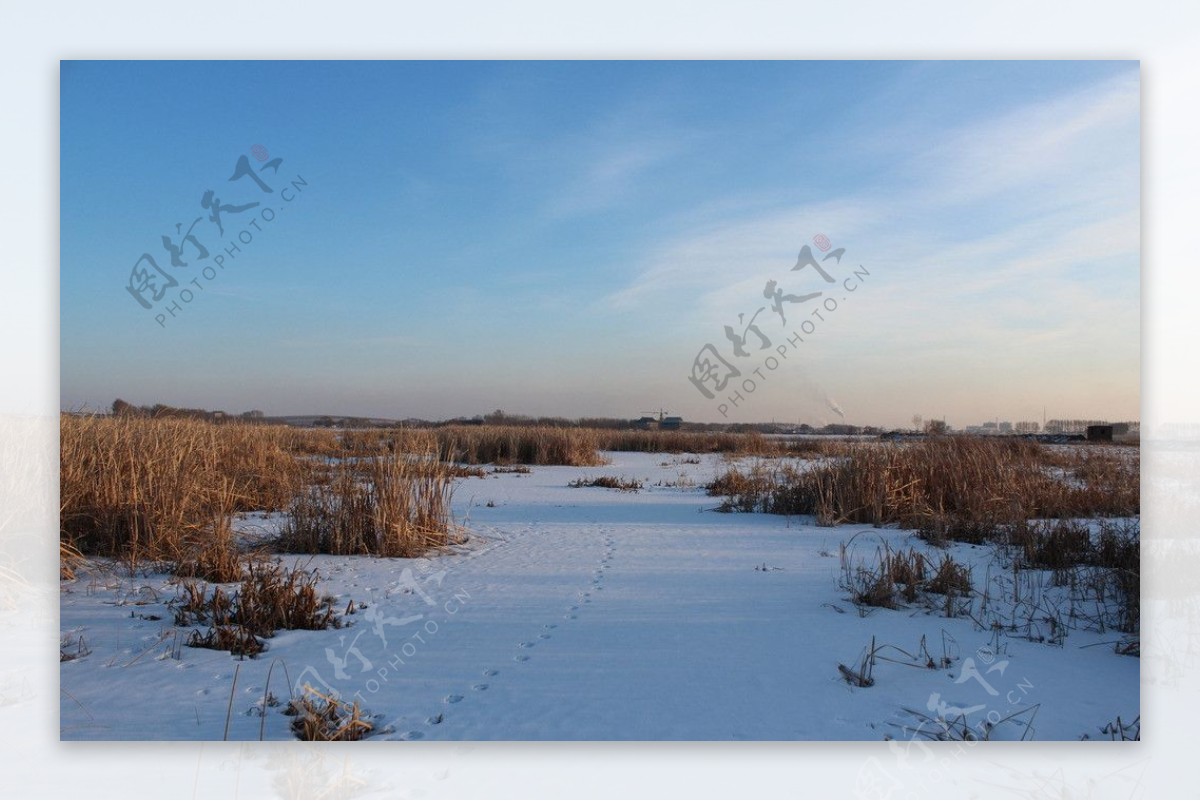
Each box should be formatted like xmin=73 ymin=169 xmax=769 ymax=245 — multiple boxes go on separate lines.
xmin=709 ymin=436 xmax=1140 ymax=534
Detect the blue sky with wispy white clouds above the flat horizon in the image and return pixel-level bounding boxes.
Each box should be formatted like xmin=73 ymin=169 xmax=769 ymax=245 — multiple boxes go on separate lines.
xmin=60 ymin=61 xmax=1141 ymax=427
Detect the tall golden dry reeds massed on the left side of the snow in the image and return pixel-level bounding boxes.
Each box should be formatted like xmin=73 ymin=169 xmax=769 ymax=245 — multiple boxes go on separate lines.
xmin=60 ymin=415 xmax=462 ymax=565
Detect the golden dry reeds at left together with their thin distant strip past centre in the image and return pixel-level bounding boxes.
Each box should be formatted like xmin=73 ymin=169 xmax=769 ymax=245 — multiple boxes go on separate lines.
xmin=59 ymin=414 xmax=825 ymax=568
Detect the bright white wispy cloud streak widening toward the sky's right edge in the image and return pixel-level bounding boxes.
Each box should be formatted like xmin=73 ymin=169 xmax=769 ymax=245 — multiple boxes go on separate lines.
xmin=606 ymin=69 xmax=1139 ymax=318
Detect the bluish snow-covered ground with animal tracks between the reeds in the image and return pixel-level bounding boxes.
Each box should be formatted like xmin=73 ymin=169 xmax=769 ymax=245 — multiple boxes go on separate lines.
xmin=60 ymin=453 xmax=1140 ymax=747
